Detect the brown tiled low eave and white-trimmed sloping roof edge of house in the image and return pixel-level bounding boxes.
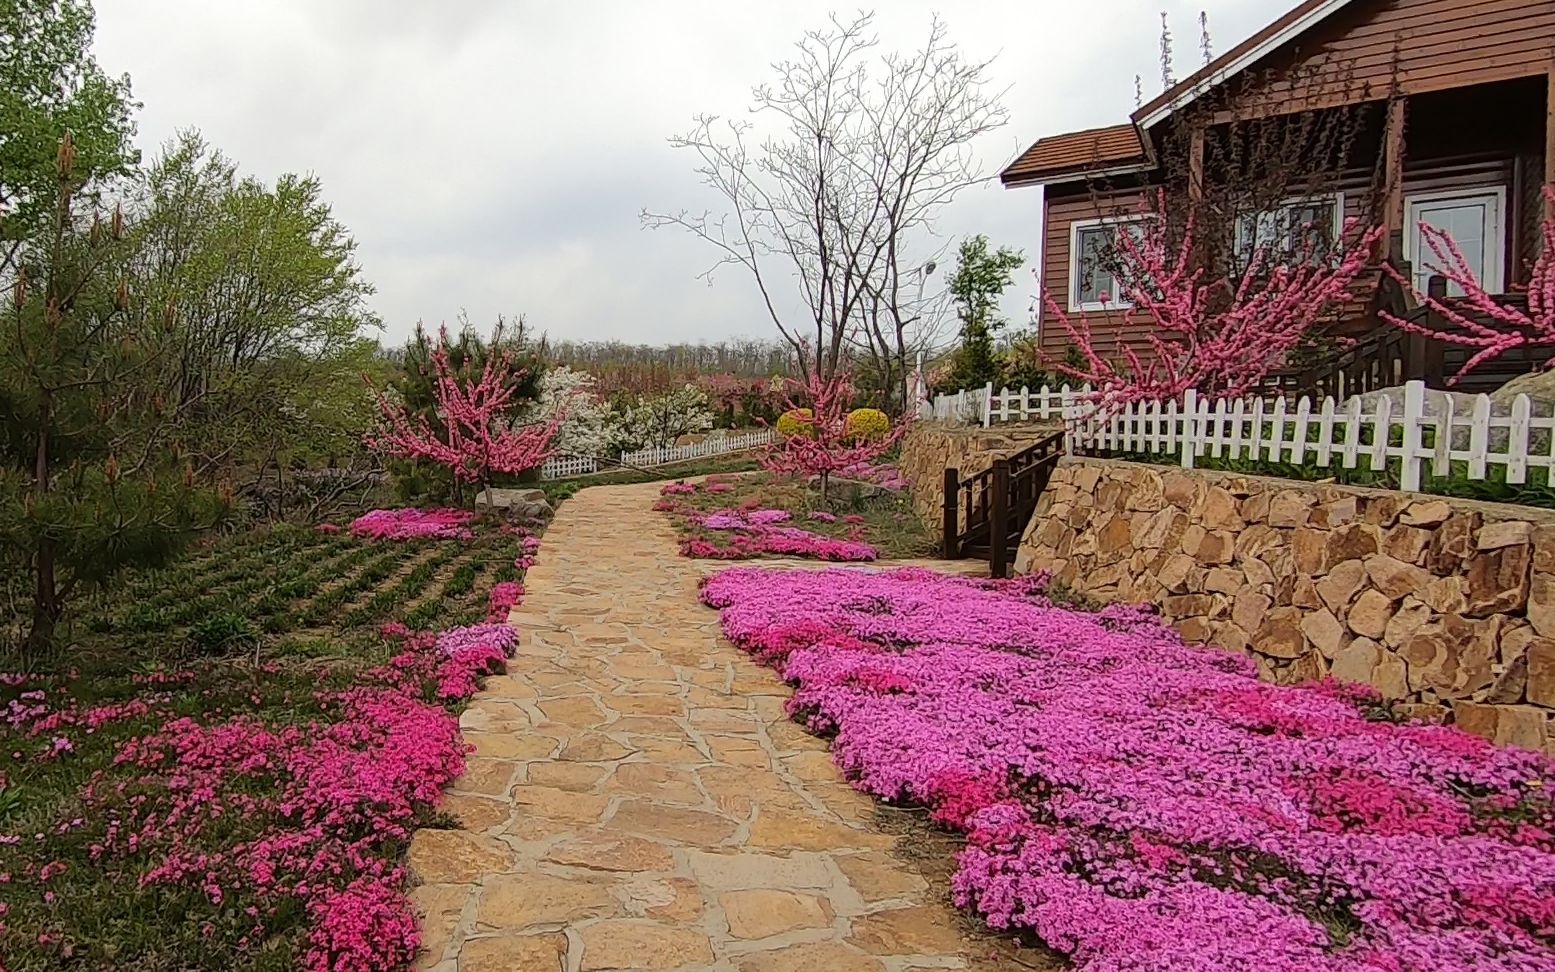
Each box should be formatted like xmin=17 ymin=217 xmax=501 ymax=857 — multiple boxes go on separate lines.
xmin=1000 ymin=0 xmax=1354 ymax=187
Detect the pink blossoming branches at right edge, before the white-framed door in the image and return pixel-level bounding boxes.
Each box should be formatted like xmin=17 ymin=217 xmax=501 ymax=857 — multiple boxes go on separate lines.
xmin=1381 ymin=185 xmax=1555 ymax=384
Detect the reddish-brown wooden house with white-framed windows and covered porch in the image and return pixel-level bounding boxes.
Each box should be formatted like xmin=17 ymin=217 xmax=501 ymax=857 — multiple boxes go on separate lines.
xmin=1001 ymin=0 xmax=1555 ymax=390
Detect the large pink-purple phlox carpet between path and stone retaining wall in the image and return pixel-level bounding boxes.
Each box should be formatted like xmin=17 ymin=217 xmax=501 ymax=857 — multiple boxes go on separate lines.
xmin=703 ymin=568 xmax=1555 ymax=972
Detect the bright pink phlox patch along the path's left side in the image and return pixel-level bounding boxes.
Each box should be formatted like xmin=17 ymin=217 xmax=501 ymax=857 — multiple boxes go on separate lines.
xmin=86 ymin=624 xmax=518 ymax=972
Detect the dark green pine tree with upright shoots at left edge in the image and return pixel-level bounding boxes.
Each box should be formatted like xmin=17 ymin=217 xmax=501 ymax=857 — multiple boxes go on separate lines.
xmin=0 ymin=135 xmax=225 ymax=663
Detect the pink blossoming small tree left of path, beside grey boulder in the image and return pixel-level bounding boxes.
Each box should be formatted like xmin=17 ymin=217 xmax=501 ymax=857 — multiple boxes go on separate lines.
xmin=367 ymin=328 xmax=564 ymax=498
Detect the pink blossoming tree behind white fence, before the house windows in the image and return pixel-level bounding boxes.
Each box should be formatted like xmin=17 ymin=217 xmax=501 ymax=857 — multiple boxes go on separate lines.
xmin=1043 ymin=194 xmax=1382 ymax=409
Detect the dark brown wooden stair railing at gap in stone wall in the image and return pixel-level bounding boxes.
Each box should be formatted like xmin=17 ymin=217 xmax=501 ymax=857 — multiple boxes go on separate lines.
xmin=941 ymin=432 xmax=1064 ymax=577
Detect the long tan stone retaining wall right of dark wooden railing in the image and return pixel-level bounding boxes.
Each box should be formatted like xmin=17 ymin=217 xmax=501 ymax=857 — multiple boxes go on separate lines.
xmin=1015 ymin=459 xmax=1555 ymax=754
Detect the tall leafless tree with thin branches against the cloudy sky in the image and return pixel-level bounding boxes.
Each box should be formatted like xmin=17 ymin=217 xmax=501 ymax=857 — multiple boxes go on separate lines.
xmin=642 ymin=14 xmax=1006 ymax=401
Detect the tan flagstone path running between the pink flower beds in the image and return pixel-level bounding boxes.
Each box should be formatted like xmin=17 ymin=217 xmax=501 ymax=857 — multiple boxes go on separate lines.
xmin=411 ymin=485 xmax=986 ymax=972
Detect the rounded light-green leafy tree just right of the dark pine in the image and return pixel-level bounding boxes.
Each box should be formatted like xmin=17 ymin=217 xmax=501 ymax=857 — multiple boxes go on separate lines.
xmin=126 ymin=131 xmax=378 ymax=482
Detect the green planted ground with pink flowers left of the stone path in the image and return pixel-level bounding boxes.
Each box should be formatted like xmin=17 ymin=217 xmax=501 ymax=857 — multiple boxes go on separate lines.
xmin=0 ymin=521 xmax=522 ymax=972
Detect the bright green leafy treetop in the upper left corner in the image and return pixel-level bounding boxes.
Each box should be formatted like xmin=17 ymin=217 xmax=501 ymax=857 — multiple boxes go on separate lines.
xmin=0 ymin=0 xmax=140 ymax=244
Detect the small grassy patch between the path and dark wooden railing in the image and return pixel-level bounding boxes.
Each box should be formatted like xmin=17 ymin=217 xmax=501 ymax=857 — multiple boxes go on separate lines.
xmin=661 ymin=473 xmax=938 ymax=560
